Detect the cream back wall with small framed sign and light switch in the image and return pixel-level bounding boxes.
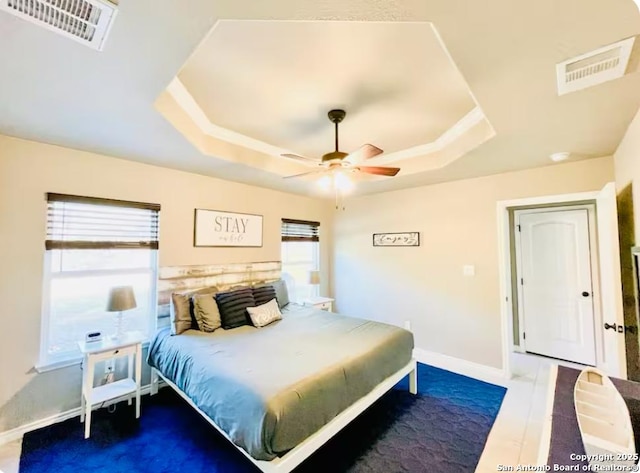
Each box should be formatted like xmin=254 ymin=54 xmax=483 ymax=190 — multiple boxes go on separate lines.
xmin=333 ymin=157 xmax=614 ymax=368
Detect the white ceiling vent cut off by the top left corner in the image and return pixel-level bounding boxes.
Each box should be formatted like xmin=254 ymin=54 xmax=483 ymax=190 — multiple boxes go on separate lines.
xmin=0 ymin=0 xmax=117 ymax=51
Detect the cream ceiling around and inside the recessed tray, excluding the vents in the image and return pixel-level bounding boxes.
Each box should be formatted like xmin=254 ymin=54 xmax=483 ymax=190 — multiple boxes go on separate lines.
xmin=0 ymin=0 xmax=640 ymax=193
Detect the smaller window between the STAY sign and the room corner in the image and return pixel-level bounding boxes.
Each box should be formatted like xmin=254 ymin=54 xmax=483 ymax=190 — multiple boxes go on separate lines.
xmin=281 ymin=218 xmax=320 ymax=302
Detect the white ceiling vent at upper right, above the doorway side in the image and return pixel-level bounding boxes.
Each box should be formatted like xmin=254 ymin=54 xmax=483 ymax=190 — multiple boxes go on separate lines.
xmin=556 ymin=37 xmax=635 ymax=95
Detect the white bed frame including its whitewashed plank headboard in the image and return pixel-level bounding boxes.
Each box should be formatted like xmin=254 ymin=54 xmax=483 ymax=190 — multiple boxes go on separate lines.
xmin=151 ymin=261 xmax=418 ymax=473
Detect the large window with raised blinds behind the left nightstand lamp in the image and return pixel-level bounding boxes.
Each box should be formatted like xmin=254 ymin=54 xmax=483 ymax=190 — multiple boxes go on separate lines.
xmin=39 ymin=193 xmax=160 ymax=366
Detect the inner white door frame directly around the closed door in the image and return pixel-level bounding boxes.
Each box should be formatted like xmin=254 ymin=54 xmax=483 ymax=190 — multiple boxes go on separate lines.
xmin=509 ymin=205 xmax=604 ymax=361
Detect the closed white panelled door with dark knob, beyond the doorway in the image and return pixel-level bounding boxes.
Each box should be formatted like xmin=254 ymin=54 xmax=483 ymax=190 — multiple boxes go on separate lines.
xmin=518 ymin=209 xmax=596 ymax=365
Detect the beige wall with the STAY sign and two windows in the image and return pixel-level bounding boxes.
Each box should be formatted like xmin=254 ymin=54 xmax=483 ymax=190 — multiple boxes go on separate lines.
xmin=0 ymin=135 xmax=333 ymax=433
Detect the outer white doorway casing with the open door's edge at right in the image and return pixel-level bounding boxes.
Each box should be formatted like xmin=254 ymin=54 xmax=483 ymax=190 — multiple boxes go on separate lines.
xmin=496 ymin=182 xmax=627 ymax=379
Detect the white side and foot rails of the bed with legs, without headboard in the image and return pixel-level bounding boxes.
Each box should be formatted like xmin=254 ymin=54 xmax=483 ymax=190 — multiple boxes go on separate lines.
xmin=151 ymin=359 xmax=418 ymax=473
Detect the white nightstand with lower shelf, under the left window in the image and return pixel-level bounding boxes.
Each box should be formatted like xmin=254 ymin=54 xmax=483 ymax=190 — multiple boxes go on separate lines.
xmin=78 ymin=332 xmax=144 ymax=438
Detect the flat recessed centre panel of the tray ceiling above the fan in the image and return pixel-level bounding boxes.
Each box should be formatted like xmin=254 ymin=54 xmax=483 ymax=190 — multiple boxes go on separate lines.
xmin=178 ymin=21 xmax=476 ymax=157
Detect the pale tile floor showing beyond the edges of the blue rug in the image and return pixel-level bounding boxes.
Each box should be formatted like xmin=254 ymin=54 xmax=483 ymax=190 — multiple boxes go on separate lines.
xmin=0 ymin=359 xmax=550 ymax=473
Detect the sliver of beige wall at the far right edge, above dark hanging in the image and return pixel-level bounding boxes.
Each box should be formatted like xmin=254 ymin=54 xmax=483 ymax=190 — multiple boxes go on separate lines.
xmin=614 ymin=105 xmax=640 ymax=242
